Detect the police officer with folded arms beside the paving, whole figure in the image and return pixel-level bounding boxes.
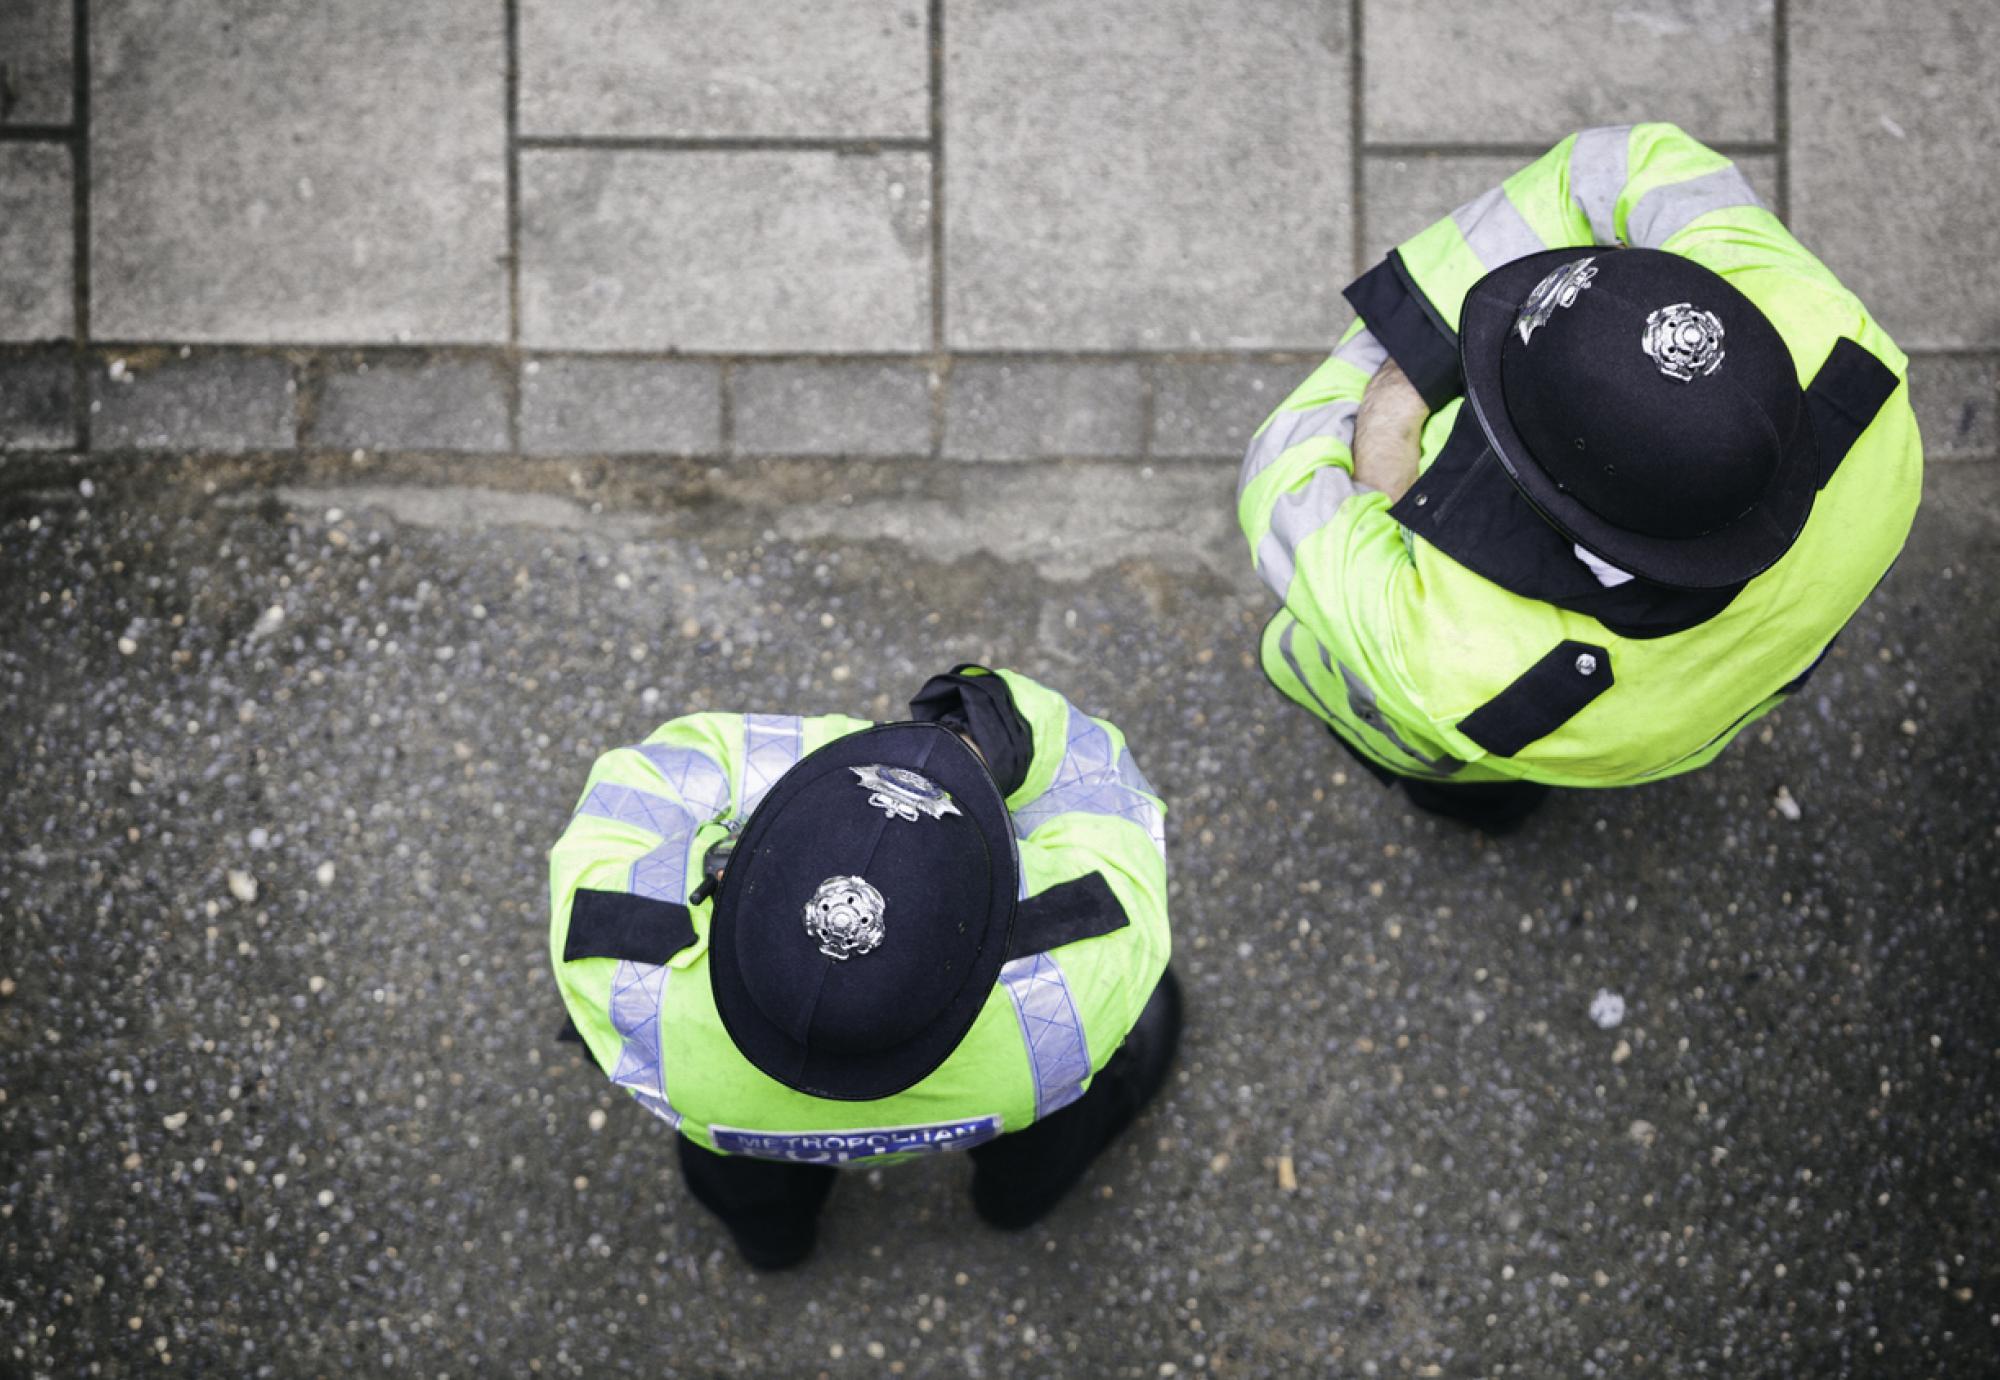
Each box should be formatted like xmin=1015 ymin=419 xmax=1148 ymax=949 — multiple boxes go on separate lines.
xmin=1236 ymin=124 xmax=1922 ymax=832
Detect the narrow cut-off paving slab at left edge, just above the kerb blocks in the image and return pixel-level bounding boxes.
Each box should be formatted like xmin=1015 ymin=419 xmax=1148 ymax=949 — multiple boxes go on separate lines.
xmin=0 ymin=144 xmax=76 ymax=340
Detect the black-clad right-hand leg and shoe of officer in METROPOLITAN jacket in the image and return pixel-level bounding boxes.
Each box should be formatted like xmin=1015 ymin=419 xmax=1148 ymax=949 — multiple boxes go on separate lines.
xmin=970 ymin=970 xmax=1182 ymax=1232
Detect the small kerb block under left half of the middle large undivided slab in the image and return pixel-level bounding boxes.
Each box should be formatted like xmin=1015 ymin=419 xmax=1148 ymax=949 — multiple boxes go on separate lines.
xmin=944 ymin=360 xmax=1144 ymax=460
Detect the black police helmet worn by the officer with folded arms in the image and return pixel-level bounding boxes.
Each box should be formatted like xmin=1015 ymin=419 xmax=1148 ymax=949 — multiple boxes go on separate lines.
xmin=1460 ymin=248 xmax=1818 ymax=588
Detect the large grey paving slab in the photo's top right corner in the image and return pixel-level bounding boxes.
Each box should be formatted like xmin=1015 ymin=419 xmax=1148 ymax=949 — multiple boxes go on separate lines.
xmin=1792 ymin=0 xmax=2000 ymax=350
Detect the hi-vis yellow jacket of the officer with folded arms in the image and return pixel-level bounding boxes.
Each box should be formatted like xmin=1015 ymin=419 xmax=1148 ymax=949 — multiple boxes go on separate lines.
xmin=1236 ymin=124 xmax=1922 ymax=786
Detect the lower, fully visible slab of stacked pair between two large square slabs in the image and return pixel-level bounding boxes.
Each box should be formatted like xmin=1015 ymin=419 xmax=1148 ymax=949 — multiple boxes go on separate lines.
xmin=520 ymin=150 xmax=930 ymax=354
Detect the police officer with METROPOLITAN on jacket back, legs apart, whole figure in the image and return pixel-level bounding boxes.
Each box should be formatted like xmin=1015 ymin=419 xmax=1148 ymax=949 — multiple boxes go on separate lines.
xmin=550 ymin=666 xmax=1180 ymax=1268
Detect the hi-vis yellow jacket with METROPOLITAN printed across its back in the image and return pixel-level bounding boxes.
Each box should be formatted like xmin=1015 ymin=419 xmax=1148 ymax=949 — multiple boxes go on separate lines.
xmin=548 ymin=668 xmax=1172 ymax=1164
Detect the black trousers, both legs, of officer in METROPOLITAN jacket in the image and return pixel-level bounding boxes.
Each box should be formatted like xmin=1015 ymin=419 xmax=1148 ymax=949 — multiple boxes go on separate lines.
xmin=680 ymin=1012 xmax=1148 ymax=1262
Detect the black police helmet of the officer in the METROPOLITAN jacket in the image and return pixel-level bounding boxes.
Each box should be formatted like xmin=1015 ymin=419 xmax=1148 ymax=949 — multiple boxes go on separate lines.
xmin=708 ymin=724 xmax=1020 ymax=1102
